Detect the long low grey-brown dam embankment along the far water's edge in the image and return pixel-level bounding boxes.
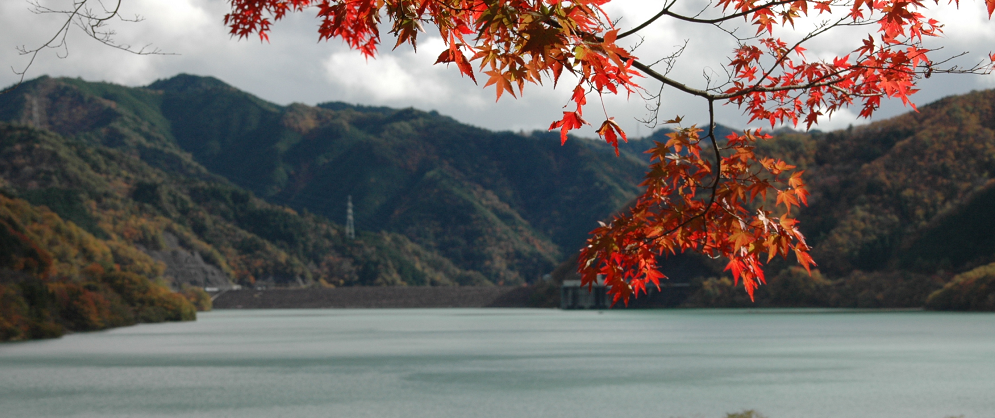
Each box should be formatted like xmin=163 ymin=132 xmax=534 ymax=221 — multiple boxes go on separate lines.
xmin=214 ymin=286 xmax=533 ymax=309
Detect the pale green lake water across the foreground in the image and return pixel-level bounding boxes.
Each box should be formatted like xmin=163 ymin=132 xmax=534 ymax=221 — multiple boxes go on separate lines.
xmin=0 ymin=309 xmax=995 ymax=418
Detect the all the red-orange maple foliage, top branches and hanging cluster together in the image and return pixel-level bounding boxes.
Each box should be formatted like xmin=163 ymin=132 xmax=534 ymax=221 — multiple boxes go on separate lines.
xmin=225 ymin=0 xmax=995 ymax=302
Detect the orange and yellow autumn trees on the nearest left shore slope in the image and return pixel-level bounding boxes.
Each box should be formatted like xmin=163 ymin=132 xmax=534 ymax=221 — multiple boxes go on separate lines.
xmin=0 ymin=193 xmax=196 ymax=341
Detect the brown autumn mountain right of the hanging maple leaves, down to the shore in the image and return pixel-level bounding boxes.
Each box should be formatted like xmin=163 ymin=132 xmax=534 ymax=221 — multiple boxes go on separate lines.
xmin=676 ymin=90 xmax=995 ymax=307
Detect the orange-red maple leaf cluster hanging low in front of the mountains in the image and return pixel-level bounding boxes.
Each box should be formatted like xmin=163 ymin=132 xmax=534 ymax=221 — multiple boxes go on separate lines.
xmin=580 ymin=126 xmax=815 ymax=303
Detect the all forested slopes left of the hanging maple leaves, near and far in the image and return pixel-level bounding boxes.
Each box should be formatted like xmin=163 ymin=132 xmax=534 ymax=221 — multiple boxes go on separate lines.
xmin=0 ymin=75 xmax=640 ymax=340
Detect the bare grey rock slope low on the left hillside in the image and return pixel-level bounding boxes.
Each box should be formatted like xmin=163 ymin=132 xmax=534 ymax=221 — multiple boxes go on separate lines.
xmin=142 ymin=232 xmax=232 ymax=289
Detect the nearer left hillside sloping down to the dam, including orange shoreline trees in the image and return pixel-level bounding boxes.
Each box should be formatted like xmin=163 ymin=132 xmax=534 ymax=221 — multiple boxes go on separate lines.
xmin=0 ymin=115 xmax=489 ymax=341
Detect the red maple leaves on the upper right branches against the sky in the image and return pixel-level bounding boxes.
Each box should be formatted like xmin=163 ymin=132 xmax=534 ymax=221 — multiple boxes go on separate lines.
xmin=719 ymin=0 xmax=944 ymax=128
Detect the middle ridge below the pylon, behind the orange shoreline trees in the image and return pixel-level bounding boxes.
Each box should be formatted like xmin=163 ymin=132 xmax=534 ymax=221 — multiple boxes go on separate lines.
xmin=0 ymin=117 xmax=485 ymax=287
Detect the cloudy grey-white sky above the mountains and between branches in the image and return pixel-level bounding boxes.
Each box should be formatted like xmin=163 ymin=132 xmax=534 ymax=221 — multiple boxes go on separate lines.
xmin=0 ymin=0 xmax=995 ymax=136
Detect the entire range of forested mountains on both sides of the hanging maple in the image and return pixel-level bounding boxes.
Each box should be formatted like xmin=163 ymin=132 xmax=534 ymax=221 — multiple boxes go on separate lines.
xmin=0 ymin=75 xmax=995 ymax=339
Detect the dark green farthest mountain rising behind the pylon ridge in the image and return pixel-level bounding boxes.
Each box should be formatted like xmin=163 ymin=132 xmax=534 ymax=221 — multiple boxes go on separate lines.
xmin=0 ymin=75 xmax=643 ymax=284
